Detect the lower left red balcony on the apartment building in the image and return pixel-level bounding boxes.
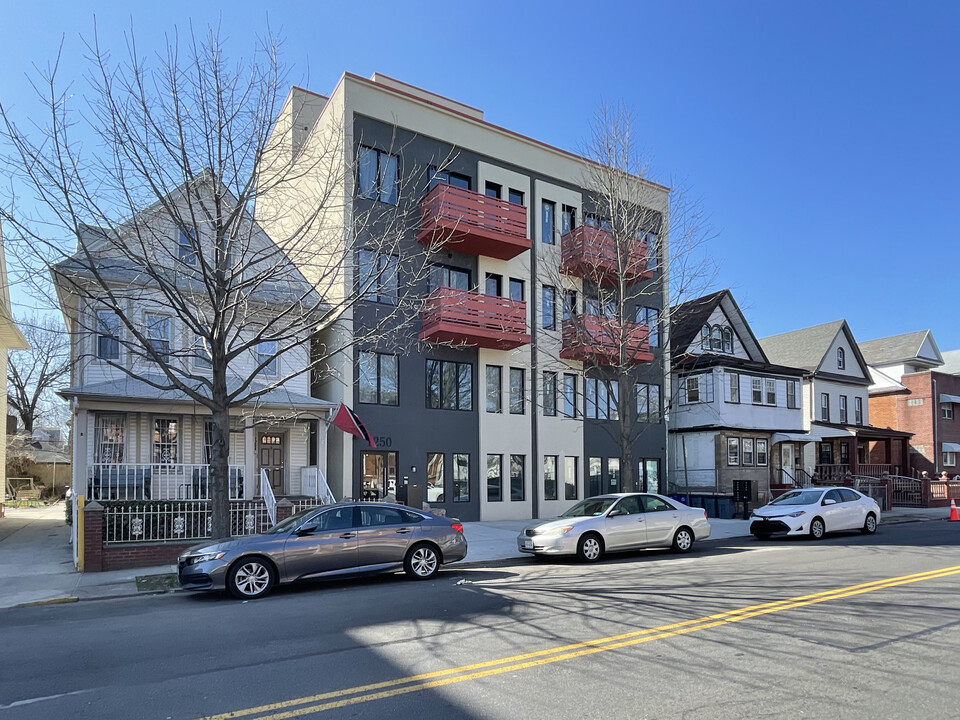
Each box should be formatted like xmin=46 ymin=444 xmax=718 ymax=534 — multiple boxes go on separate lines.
xmin=420 ymin=287 xmax=530 ymax=350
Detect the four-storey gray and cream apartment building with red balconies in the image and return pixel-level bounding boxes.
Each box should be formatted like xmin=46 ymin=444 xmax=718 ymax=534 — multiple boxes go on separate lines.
xmin=258 ymin=74 xmax=668 ymax=520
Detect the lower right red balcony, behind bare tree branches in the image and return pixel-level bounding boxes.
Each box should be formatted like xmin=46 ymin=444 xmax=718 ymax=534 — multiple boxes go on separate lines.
xmin=560 ymin=315 xmax=653 ymax=365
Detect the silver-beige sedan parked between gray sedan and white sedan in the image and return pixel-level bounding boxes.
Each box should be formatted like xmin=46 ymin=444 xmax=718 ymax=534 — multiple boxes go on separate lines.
xmin=517 ymin=493 xmax=710 ymax=562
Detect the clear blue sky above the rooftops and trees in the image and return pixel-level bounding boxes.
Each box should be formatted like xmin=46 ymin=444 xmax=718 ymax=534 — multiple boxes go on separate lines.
xmin=0 ymin=0 xmax=960 ymax=350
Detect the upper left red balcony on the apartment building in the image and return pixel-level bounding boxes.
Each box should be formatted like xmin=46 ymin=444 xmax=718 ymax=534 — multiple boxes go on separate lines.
xmin=417 ymin=184 xmax=530 ymax=260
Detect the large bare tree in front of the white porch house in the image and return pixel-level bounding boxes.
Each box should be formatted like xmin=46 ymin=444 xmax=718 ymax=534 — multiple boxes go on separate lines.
xmin=0 ymin=29 xmax=438 ymax=537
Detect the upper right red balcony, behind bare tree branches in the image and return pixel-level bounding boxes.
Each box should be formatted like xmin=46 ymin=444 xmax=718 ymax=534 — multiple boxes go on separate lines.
xmin=560 ymin=225 xmax=653 ymax=285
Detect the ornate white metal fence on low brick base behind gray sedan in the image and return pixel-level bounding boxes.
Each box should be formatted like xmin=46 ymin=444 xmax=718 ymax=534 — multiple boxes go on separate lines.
xmin=102 ymin=500 xmax=273 ymax=544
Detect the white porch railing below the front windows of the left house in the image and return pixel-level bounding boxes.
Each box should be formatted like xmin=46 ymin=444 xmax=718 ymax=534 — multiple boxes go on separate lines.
xmin=87 ymin=463 xmax=243 ymax=500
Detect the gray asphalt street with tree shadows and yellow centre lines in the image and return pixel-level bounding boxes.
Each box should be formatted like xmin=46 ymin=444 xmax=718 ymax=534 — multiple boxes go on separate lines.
xmin=0 ymin=522 xmax=960 ymax=720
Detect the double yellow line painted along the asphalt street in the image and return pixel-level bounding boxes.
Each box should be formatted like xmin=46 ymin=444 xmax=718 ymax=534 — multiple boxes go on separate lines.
xmin=201 ymin=565 xmax=960 ymax=720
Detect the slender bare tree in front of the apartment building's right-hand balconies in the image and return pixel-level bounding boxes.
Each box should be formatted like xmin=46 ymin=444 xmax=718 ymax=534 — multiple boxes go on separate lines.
xmin=541 ymin=106 xmax=714 ymax=490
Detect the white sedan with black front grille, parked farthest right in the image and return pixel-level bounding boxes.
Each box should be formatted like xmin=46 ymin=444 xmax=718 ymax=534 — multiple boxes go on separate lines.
xmin=750 ymin=487 xmax=880 ymax=540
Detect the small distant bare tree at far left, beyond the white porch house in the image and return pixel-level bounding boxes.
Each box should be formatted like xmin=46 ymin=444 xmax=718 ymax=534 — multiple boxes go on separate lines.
xmin=7 ymin=316 xmax=70 ymax=433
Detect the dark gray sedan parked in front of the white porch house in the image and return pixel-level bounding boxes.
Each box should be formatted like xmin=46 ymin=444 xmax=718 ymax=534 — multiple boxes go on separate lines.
xmin=178 ymin=502 xmax=467 ymax=599
